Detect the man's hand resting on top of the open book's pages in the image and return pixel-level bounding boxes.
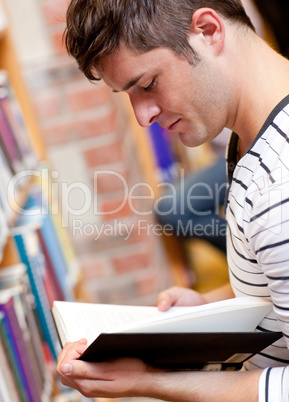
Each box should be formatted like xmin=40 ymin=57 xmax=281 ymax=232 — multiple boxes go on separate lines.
xmin=157 ymin=286 xmax=207 ymax=311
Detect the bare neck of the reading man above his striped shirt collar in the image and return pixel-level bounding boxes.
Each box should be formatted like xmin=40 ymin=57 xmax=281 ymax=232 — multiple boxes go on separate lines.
xmin=227 ymin=35 xmax=289 ymax=155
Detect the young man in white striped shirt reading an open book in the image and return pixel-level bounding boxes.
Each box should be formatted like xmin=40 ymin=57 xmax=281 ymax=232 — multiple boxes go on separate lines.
xmin=57 ymin=0 xmax=289 ymax=402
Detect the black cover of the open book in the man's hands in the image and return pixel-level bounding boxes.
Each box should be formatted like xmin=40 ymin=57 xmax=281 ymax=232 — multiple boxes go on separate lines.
xmin=80 ymin=332 xmax=282 ymax=369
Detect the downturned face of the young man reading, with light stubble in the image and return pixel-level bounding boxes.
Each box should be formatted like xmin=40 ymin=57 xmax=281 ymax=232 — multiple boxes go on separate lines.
xmin=100 ymin=44 xmax=227 ymax=146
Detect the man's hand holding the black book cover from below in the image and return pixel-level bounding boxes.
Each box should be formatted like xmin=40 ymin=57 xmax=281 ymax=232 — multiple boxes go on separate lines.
xmin=56 ymin=339 xmax=154 ymax=398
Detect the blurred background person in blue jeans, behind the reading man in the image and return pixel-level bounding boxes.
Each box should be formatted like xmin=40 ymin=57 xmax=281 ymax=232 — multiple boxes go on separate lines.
xmin=155 ymin=0 xmax=264 ymax=253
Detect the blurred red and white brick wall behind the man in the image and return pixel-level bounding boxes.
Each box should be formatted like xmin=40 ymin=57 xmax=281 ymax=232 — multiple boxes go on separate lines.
xmin=15 ymin=0 xmax=171 ymax=304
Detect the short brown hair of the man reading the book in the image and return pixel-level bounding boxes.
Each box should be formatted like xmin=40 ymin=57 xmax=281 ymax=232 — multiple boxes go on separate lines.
xmin=64 ymin=0 xmax=254 ymax=80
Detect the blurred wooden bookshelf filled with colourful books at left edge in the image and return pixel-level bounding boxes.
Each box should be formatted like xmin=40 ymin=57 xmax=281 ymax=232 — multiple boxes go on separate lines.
xmin=0 ymin=18 xmax=79 ymax=402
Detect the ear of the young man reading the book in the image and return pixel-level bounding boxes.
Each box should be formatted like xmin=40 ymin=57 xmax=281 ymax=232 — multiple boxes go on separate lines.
xmin=191 ymin=8 xmax=225 ymax=54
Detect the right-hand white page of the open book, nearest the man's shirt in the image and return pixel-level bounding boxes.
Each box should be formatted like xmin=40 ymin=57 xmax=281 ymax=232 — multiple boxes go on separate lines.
xmin=110 ymin=297 xmax=272 ymax=333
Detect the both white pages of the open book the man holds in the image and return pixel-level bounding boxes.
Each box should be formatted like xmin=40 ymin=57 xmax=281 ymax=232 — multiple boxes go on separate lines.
xmin=53 ymin=297 xmax=272 ymax=344
